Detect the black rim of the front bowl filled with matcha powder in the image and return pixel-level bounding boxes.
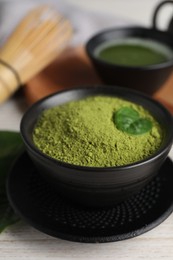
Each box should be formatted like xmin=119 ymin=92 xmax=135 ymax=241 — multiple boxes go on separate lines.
xmin=20 ymin=85 xmax=173 ymax=171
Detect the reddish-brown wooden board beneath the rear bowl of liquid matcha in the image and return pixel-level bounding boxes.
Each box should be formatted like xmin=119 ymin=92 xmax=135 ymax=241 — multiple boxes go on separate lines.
xmin=24 ymin=47 xmax=173 ymax=114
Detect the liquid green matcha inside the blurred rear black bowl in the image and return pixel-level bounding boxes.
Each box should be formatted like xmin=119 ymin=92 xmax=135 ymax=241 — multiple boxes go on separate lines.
xmin=95 ymin=38 xmax=173 ymax=66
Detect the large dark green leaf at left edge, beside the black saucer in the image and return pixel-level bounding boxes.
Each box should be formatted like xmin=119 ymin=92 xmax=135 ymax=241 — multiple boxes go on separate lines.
xmin=0 ymin=131 xmax=23 ymax=233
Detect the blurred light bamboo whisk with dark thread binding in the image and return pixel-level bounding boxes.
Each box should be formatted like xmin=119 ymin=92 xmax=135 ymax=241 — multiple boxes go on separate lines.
xmin=0 ymin=6 xmax=72 ymax=103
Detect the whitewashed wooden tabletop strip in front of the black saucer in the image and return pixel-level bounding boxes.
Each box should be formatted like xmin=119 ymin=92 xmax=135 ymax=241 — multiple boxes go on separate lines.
xmin=0 ymin=215 xmax=173 ymax=260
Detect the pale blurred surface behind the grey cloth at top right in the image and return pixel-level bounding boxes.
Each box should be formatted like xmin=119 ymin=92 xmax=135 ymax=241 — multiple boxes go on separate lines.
xmin=67 ymin=0 xmax=173 ymax=28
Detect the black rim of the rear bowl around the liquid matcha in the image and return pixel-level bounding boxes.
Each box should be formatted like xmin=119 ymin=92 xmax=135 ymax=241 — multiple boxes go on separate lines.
xmin=85 ymin=26 xmax=173 ymax=71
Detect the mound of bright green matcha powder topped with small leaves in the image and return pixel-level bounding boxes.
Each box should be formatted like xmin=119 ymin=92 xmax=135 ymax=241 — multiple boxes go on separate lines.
xmin=33 ymin=96 xmax=163 ymax=167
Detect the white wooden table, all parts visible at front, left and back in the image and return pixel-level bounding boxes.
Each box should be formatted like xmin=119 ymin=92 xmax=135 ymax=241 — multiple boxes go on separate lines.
xmin=0 ymin=0 xmax=173 ymax=260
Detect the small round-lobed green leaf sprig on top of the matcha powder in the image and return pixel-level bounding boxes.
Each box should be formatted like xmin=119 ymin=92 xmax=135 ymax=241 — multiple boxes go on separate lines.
xmin=114 ymin=107 xmax=152 ymax=135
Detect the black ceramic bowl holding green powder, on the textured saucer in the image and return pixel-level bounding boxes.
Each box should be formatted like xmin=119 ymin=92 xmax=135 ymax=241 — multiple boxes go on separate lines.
xmin=21 ymin=86 xmax=173 ymax=207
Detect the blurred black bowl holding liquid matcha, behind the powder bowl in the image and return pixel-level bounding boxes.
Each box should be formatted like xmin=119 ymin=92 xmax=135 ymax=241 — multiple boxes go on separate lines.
xmin=86 ymin=27 xmax=173 ymax=95
